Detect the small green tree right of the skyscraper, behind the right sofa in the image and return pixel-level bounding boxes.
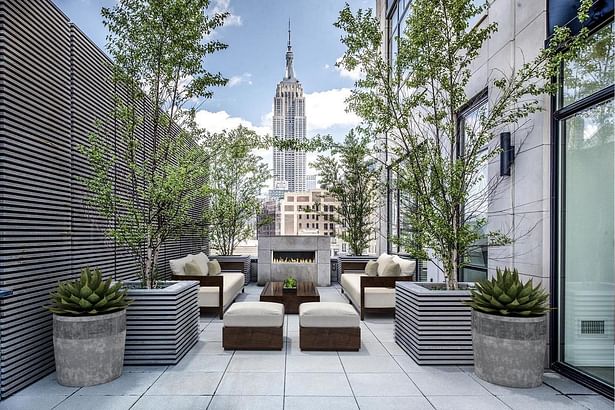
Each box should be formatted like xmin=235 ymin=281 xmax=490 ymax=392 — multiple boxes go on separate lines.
xmin=314 ymin=131 xmax=380 ymax=255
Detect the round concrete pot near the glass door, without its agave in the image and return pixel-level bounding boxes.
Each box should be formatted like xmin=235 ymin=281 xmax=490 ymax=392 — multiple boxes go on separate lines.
xmin=472 ymin=310 xmax=547 ymax=388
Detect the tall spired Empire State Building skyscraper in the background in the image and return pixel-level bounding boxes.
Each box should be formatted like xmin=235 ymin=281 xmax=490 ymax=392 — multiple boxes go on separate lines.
xmin=273 ymin=21 xmax=306 ymax=192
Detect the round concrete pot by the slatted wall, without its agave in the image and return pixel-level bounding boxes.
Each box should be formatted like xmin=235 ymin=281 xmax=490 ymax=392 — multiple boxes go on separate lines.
xmin=53 ymin=310 xmax=126 ymax=386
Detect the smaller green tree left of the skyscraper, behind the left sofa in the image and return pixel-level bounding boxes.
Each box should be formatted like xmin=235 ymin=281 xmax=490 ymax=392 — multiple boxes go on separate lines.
xmin=204 ymin=126 xmax=270 ymax=255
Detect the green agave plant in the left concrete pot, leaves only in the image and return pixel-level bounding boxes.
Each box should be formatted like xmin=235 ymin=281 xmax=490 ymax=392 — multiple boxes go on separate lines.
xmin=49 ymin=267 xmax=130 ymax=316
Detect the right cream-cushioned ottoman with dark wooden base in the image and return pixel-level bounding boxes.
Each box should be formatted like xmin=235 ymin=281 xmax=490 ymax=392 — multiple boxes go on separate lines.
xmin=299 ymin=302 xmax=361 ymax=351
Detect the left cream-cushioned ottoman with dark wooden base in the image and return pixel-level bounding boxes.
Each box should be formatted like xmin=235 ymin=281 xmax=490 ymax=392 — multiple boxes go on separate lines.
xmin=222 ymin=302 xmax=284 ymax=350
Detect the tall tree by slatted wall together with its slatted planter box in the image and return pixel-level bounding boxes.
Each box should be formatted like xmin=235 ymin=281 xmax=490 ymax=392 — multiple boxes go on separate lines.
xmin=81 ymin=0 xmax=228 ymax=364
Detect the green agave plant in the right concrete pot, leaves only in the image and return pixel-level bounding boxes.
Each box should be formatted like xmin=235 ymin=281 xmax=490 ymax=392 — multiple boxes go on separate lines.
xmin=465 ymin=268 xmax=549 ymax=317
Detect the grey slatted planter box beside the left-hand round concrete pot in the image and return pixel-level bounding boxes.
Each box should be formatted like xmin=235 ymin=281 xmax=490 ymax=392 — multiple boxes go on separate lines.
xmin=124 ymin=281 xmax=200 ymax=365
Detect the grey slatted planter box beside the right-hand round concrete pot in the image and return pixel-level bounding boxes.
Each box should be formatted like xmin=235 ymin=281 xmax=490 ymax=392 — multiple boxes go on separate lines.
xmin=395 ymin=282 xmax=473 ymax=365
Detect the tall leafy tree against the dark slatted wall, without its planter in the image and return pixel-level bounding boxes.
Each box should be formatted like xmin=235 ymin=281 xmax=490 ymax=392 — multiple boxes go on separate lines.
xmin=82 ymin=0 xmax=227 ymax=288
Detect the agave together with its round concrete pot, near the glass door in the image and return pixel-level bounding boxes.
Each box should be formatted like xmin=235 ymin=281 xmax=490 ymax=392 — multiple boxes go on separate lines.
xmin=467 ymin=268 xmax=549 ymax=387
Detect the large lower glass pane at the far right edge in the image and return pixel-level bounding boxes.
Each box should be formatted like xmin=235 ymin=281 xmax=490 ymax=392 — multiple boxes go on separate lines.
xmin=560 ymin=100 xmax=615 ymax=385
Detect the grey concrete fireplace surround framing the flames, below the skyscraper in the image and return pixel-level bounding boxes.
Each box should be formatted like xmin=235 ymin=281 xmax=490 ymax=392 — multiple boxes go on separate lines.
xmin=258 ymin=236 xmax=331 ymax=286
